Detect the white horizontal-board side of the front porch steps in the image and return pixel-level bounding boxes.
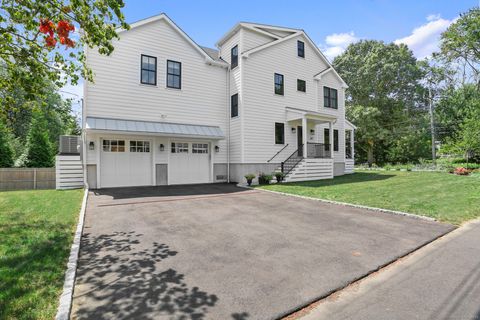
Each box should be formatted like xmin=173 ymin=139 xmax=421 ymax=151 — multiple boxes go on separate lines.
xmin=284 ymin=158 xmax=333 ymax=182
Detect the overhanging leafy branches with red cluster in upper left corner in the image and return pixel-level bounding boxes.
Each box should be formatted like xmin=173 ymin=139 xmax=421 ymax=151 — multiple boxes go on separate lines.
xmin=0 ymin=0 xmax=128 ymax=107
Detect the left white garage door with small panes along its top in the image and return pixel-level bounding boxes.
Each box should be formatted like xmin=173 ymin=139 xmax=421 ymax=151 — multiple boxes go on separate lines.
xmin=100 ymin=139 xmax=152 ymax=188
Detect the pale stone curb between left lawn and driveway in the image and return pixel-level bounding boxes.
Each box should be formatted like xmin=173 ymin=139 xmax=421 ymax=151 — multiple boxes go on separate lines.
xmin=55 ymin=188 xmax=88 ymax=320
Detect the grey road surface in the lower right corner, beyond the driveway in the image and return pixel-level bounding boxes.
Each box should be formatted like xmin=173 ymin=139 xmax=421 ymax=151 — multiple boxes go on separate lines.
xmin=299 ymin=220 xmax=480 ymax=320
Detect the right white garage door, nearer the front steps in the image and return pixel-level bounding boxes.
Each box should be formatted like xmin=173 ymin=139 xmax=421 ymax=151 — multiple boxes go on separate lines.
xmin=169 ymin=142 xmax=210 ymax=184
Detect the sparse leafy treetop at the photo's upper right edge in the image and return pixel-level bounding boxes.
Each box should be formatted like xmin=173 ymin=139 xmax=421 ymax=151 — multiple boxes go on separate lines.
xmin=436 ymin=7 xmax=480 ymax=88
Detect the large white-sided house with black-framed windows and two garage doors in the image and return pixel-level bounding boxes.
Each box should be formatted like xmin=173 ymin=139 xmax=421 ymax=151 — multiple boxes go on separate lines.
xmin=83 ymin=14 xmax=355 ymax=188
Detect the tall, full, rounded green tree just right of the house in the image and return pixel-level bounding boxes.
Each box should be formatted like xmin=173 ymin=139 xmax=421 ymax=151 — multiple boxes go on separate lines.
xmin=333 ymin=40 xmax=425 ymax=164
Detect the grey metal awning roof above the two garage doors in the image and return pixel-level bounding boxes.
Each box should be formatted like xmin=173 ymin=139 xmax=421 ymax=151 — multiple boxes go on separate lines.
xmin=86 ymin=117 xmax=225 ymax=140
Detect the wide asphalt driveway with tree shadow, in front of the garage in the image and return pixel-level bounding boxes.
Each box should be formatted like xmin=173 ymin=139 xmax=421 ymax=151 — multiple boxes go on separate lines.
xmin=72 ymin=184 xmax=452 ymax=320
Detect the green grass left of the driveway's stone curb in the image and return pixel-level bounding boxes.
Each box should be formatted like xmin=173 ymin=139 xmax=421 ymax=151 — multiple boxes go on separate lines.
xmin=0 ymin=190 xmax=83 ymax=319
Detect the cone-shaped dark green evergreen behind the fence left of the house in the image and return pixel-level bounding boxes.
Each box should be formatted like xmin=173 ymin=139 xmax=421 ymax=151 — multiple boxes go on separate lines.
xmin=25 ymin=113 xmax=54 ymax=168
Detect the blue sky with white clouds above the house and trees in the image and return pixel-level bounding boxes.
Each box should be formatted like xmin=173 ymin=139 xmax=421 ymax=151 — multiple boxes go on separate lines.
xmin=62 ymin=0 xmax=480 ymax=106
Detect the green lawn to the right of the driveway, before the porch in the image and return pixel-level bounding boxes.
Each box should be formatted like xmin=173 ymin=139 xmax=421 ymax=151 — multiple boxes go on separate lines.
xmin=259 ymin=171 xmax=480 ymax=225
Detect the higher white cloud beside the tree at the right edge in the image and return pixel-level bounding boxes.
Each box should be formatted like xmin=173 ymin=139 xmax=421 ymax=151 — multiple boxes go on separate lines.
xmin=395 ymin=14 xmax=455 ymax=59
